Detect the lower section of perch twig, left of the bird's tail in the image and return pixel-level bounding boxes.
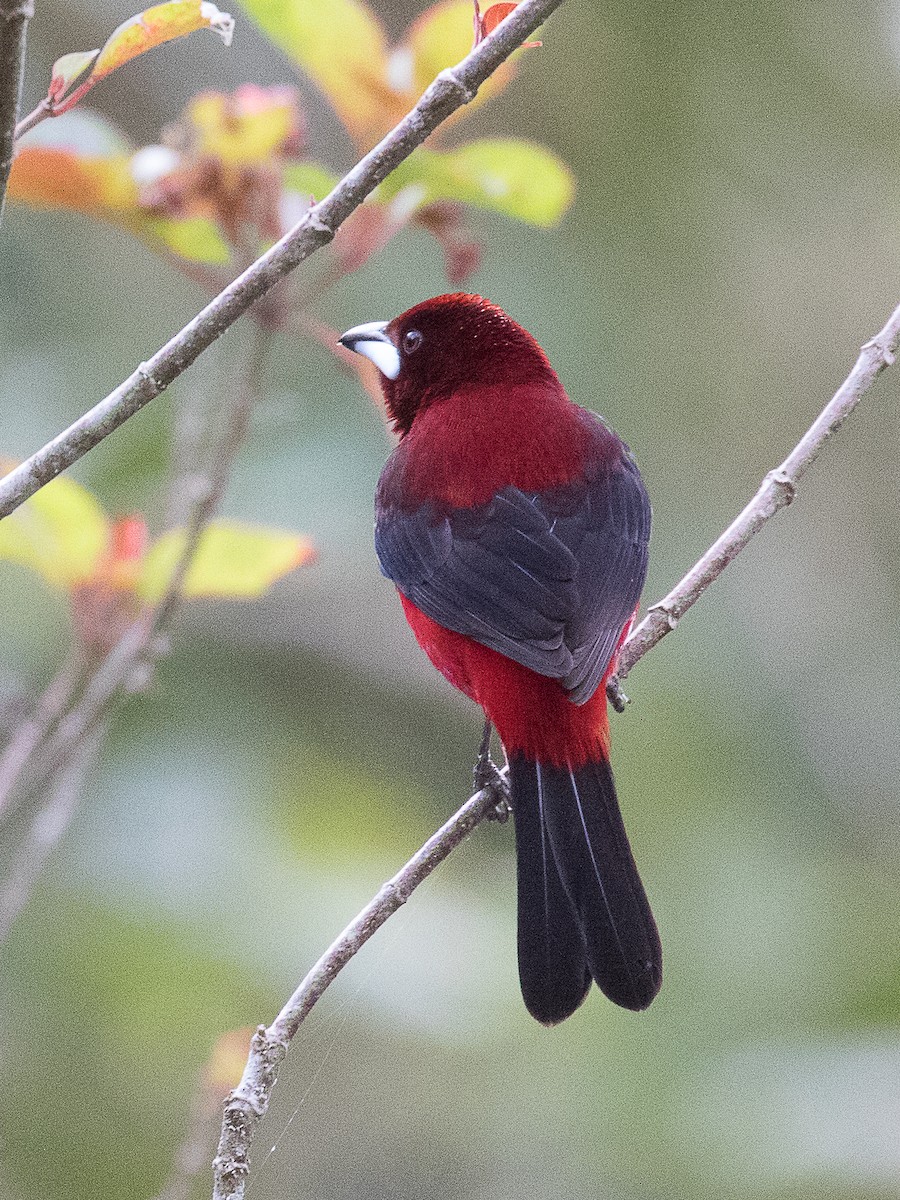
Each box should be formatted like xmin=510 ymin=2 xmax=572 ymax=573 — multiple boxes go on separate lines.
xmin=212 ymin=787 xmax=508 ymax=1200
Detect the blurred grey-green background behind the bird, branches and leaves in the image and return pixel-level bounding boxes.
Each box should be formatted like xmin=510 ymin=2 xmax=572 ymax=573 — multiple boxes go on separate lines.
xmin=0 ymin=0 xmax=900 ymax=1200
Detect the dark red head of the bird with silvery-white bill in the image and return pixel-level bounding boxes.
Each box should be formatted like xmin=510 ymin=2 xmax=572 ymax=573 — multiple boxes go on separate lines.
xmin=341 ymin=294 xmax=556 ymax=437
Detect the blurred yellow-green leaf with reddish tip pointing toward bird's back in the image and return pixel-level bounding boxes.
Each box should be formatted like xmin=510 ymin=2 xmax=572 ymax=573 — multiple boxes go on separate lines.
xmin=135 ymin=521 xmax=316 ymax=602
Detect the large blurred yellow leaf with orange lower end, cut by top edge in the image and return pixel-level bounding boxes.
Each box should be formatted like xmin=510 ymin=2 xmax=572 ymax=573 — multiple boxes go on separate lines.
xmin=240 ymin=0 xmax=393 ymax=140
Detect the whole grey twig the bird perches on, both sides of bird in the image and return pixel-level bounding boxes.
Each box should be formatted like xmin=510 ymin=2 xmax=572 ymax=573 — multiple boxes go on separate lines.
xmin=214 ymin=295 xmax=900 ymax=1200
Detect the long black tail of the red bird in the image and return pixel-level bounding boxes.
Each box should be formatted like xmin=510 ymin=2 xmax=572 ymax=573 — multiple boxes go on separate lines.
xmin=510 ymin=754 xmax=662 ymax=1025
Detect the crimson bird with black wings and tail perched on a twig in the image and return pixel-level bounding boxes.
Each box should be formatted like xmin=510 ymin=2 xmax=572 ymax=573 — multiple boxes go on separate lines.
xmin=340 ymin=293 xmax=662 ymax=1026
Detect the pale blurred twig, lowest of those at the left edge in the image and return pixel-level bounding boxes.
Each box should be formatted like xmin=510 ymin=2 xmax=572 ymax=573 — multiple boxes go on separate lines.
xmin=0 ymin=728 xmax=103 ymax=944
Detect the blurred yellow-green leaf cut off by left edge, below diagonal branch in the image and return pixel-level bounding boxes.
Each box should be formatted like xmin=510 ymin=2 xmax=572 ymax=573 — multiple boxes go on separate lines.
xmin=0 ymin=476 xmax=109 ymax=588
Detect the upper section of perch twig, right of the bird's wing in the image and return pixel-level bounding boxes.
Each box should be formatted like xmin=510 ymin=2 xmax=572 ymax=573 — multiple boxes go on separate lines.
xmin=610 ymin=298 xmax=900 ymax=703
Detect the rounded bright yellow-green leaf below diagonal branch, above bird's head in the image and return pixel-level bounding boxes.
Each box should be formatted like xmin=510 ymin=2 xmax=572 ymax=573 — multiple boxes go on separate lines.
xmin=378 ymin=138 xmax=575 ymax=226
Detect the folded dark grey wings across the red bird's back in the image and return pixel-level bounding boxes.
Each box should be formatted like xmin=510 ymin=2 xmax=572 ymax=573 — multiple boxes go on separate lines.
xmin=376 ymin=419 xmax=650 ymax=703
